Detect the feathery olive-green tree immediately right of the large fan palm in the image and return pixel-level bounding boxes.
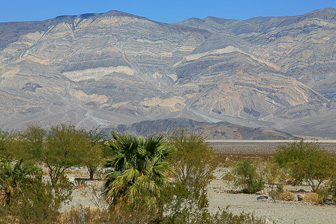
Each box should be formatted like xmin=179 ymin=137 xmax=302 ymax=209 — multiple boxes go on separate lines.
xmin=168 ymin=131 xmax=218 ymax=209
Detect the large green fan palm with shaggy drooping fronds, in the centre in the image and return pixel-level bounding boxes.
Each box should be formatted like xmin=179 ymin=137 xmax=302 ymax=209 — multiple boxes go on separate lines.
xmin=104 ymin=132 xmax=171 ymax=214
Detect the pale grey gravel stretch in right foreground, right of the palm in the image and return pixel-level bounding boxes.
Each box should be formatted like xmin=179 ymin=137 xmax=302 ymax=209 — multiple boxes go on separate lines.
xmin=208 ymin=180 xmax=336 ymax=224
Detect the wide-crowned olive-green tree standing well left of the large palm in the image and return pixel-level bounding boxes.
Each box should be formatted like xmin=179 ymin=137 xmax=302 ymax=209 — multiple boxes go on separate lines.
xmin=14 ymin=124 xmax=89 ymax=187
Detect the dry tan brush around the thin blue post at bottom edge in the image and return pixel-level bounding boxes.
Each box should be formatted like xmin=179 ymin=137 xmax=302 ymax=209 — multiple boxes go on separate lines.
xmin=58 ymin=207 xmax=112 ymax=224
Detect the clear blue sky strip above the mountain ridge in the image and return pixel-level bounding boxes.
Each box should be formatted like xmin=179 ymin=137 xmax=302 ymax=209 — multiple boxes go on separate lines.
xmin=0 ymin=0 xmax=336 ymax=23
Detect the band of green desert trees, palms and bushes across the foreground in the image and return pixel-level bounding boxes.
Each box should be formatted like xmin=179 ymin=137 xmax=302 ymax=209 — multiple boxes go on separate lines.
xmin=0 ymin=124 xmax=336 ymax=223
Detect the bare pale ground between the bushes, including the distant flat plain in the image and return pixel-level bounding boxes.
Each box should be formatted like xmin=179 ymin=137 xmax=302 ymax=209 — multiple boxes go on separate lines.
xmin=61 ymin=141 xmax=336 ymax=224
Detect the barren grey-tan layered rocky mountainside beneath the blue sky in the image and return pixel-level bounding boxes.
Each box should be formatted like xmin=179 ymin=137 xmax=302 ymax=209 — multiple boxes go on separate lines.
xmin=0 ymin=9 xmax=336 ymax=137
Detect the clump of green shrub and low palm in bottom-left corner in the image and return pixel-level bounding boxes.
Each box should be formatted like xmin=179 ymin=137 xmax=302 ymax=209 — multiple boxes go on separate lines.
xmin=0 ymin=159 xmax=68 ymax=223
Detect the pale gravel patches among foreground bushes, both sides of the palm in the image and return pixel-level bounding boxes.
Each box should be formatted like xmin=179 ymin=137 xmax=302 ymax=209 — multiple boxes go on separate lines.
xmin=62 ymin=177 xmax=336 ymax=224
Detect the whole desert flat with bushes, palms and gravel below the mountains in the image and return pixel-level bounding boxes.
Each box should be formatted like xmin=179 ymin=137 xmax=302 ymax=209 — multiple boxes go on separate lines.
xmin=0 ymin=124 xmax=336 ymax=223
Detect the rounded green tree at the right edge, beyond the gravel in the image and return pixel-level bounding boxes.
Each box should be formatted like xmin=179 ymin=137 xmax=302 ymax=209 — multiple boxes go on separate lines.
xmin=274 ymin=140 xmax=336 ymax=192
